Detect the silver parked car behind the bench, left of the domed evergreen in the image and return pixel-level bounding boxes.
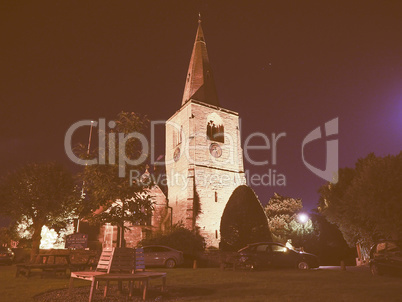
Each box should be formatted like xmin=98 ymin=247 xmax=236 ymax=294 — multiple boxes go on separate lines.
xmin=144 ymin=245 xmax=184 ymax=268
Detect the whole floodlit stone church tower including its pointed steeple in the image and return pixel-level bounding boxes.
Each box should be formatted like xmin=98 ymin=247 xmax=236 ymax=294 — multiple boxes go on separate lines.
xmin=165 ymin=20 xmax=246 ymax=247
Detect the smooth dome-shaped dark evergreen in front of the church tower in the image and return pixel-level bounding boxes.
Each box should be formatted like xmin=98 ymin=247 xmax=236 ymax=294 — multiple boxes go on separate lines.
xmin=220 ymin=185 xmax=272 ymax=251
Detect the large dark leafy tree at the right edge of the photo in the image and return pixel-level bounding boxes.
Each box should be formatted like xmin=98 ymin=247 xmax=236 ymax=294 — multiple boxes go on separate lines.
xmin=318 ymin=152 xmax=402 ymax=246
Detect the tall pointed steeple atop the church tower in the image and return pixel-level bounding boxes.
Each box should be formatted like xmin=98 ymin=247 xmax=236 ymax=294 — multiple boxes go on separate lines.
xmin=181 ymin=16 xmax=219 ymax=106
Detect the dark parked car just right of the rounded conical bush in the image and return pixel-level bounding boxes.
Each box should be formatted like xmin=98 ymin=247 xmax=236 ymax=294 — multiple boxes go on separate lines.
xmin=238 ymin=242 xmax=319 ymax=269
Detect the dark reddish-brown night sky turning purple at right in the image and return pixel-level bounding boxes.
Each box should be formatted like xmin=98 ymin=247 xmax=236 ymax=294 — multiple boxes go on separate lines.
xmin=0 ymin=1 xmax=402 ymax=209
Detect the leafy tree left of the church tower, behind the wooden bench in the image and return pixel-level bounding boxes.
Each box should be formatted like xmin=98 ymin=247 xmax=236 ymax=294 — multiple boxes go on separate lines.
xmin=78 ymin=112 xmax=153 ymax=246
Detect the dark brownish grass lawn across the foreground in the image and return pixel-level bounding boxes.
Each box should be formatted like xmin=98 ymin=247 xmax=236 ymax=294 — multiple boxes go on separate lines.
xmin=0 ymin=266 xmax=402 ymax=302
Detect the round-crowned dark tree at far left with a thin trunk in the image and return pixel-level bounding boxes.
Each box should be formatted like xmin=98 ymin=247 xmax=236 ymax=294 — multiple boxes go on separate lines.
xmin=0 ymin=162 xmax=80 ymax=259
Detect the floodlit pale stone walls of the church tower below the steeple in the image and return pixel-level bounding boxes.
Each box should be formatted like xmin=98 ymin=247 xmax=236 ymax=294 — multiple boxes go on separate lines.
xmin=166 ymin=101 xmax=245 ymax=247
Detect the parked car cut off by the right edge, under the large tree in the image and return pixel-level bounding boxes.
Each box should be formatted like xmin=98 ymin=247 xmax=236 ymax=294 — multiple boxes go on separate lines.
xmin=370 ymin=240 xmax=402 ymax=275
